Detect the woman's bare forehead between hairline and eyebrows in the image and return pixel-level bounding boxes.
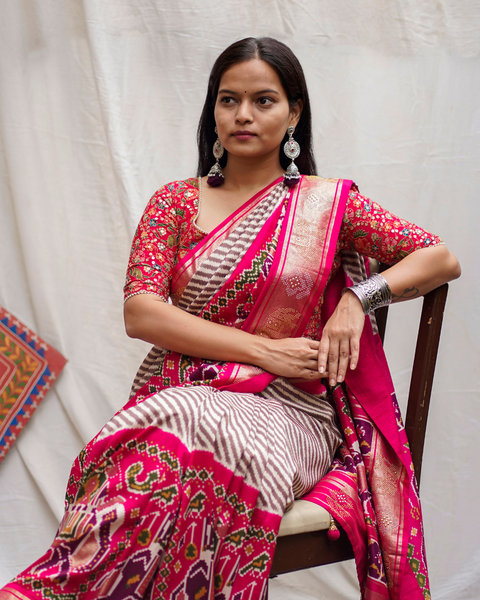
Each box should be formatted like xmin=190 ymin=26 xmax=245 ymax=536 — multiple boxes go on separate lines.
xmin=219 ymin=59 xmax=284 ymax=95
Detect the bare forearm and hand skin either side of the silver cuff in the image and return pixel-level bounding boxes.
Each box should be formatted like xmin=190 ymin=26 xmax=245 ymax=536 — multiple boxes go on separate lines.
xmin=318 ymin=245 xmax=461 ymax=385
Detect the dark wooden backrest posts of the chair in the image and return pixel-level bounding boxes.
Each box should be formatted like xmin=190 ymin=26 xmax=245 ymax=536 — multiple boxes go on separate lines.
xmin=376 ymin=283 xmax=448 ymax=486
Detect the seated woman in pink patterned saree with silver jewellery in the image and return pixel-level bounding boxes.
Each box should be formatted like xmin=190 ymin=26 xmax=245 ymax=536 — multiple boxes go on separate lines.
xmin=0 ymin=38 xmax=460 ymax=600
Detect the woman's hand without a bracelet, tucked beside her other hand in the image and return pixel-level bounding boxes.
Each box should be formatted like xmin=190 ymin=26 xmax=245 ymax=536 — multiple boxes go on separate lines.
xmin=255 ymin=337 xmax=327 ymax=380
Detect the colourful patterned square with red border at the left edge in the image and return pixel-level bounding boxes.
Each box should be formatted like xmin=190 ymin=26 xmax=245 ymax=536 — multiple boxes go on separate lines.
xmin=0 ymin=306 xmax=67 ymax=462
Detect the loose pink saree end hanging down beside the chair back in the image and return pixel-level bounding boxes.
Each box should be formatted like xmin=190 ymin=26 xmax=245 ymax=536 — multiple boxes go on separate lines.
xmin=304 ymin=260 xmax=431 ymax=600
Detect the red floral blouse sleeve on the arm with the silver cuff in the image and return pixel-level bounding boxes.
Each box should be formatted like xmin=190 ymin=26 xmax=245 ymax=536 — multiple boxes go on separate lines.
xmin=338 ymin=189 xmax=443 ymax=265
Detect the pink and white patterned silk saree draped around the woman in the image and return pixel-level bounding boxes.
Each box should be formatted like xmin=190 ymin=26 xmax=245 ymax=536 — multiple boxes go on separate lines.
xmin=0 ymin=177 xmax=428 ymax=600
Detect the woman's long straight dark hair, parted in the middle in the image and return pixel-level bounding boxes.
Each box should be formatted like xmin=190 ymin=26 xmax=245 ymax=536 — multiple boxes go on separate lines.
xmin=197 ymin=37 xmax=317 ymax=177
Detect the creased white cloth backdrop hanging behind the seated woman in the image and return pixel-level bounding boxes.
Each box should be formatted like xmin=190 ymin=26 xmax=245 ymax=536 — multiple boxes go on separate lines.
xmin=0 ymin=0 xmax=480 ymax=600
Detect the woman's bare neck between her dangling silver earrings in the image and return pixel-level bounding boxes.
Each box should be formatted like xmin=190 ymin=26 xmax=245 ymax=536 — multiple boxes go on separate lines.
xmin=223 ymin=151 xmax=285 ymax=191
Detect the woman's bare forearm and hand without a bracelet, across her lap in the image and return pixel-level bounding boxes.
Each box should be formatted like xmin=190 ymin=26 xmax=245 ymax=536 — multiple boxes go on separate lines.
xmin=124 ymin=294 xmax=322 ymax=379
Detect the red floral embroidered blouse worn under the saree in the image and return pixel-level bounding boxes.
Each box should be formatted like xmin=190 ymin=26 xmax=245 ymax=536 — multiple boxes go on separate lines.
xmin=124 ymin=178 xmax=442 ymax=300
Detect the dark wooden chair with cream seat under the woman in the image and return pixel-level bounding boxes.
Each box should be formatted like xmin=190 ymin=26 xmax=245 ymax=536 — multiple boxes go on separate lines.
xmin=270 ymin=284 xmax=448 ymax=577
